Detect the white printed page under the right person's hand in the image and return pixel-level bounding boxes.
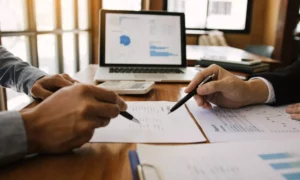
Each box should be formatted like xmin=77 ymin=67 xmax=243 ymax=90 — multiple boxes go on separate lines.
xmin=187 ymin=100 xmax=300 ymax=142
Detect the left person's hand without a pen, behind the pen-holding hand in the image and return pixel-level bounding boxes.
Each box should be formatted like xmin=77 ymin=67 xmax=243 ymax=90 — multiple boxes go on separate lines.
xmin=31 ymin=74 xmax=78 ymax=100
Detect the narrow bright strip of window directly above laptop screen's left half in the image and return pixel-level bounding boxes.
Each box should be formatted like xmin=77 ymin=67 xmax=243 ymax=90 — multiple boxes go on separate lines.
xmin=102 ymin=0 xmax=142 ymax=11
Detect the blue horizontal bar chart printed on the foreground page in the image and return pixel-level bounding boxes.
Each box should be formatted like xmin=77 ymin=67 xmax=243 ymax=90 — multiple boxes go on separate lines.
xmin=259 ymin=152 xmax=300 ymax=180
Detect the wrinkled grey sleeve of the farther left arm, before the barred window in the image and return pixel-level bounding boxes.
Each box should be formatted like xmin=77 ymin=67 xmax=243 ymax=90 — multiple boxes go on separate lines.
xmin=0 ymin=46 xmax=47 ymax=96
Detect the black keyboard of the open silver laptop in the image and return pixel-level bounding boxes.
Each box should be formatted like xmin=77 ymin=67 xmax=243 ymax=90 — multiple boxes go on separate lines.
xmin=109 ymin=67 xmax=183 ymax=74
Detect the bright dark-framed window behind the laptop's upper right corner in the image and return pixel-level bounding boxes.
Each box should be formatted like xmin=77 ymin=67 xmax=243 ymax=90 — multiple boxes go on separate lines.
xmin=167 ymin=0 xmax=252 ymax=33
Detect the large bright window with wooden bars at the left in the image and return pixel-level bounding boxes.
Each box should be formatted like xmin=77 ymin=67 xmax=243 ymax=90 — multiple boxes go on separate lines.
xmin=0 ymin=0 xmax=92 ymax=110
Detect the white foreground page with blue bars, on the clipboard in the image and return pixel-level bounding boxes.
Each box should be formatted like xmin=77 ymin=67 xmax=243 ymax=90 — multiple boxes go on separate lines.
xmin=137 ymin=139 xmax=300 ymax=180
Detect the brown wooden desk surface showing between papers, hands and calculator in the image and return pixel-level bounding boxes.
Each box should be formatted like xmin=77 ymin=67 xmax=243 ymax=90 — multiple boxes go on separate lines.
xmin=0 ymin=65 xmax=199 ymax=180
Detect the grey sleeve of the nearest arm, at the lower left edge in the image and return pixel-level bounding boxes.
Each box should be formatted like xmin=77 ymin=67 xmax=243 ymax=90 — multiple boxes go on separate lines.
xmin=0 ymin=111 xmax=27 ymax=166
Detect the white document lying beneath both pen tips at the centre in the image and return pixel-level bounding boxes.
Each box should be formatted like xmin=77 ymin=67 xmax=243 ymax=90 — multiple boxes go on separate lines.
xmin=91 ymin=101 xmax=206 ymax=143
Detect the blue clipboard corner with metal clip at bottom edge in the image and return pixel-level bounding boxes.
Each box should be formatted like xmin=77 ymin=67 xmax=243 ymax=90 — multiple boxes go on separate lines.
xmin=128 ymin=151 xmax=162 ymax=180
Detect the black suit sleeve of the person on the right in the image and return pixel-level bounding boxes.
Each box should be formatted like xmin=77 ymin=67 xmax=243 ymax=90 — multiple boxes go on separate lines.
xmin=254 ymin=61 xmax=300 ymax=105
